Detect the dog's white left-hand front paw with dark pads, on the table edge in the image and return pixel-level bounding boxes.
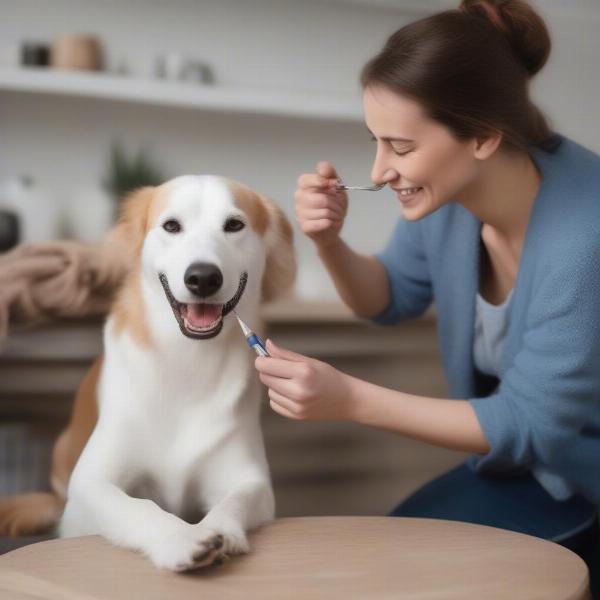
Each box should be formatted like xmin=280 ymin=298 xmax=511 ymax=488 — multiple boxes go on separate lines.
xmin=148 ymin=526 xmax=224 ymax=572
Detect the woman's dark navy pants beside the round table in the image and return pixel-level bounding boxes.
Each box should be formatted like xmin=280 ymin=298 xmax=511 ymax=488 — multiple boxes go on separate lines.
xmin=390 ymin=465 xmax=600 ymax=600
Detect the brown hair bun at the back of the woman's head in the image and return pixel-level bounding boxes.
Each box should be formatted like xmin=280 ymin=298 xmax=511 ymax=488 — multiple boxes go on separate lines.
xmin=460 ymin=0 xmax=551 ymax=76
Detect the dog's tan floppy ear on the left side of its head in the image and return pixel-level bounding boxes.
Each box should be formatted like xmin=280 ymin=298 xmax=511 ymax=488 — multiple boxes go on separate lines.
xmin=106 ymin=186 xmax=156 ymax=259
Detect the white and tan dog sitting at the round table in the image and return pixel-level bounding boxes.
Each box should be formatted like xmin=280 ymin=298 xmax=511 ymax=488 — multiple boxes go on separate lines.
xmin=0 ymin=176 xmax=295 ymax=571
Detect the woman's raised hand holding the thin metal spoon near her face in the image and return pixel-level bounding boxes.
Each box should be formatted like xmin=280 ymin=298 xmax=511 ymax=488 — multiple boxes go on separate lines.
xmin=294 ymin=162 xmax=348 ymax=247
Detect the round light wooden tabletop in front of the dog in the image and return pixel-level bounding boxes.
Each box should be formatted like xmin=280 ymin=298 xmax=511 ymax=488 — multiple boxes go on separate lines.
xmin=0 ymin=517 xmax=589 ymax=600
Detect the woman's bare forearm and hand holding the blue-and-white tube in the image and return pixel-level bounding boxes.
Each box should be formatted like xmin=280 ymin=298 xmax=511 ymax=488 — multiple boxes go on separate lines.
xmin=254 ymin=341 xmax=490 ymax=454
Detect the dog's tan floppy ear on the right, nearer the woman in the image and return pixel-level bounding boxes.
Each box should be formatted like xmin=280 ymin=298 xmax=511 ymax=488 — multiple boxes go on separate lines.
xmin=260 ymin=195 xmax=296 ymax=302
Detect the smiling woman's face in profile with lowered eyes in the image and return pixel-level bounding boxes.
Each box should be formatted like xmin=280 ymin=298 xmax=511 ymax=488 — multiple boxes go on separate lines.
xmin=363 ymin=86 xmax=480 ymax=221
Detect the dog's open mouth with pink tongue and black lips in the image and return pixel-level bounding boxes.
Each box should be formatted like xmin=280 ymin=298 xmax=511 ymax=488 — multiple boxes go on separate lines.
xmin=158 ymin=272 xmax=248 ymax=340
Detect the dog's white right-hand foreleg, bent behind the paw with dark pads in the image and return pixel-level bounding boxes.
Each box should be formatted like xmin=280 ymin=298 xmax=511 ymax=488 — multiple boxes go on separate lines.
xmin=196 ymin=478 xmax=275 ymax=555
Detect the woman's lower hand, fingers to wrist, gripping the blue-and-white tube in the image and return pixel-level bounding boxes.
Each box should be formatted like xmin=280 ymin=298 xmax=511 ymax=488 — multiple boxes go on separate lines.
xmin=254 ymin=340 xmax=352 ymax=421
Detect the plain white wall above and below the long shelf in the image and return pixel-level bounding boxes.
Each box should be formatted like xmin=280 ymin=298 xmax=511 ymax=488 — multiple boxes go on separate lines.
xmin=0 ymin=0 xmax=600 ymax=297
